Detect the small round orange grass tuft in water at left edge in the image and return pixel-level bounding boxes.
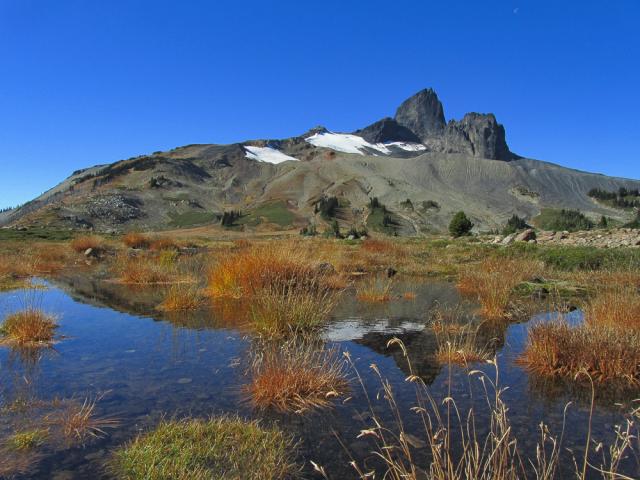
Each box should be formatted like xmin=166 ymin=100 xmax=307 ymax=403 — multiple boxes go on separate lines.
xmin=0 ymin=307 xmax=58 ymax=346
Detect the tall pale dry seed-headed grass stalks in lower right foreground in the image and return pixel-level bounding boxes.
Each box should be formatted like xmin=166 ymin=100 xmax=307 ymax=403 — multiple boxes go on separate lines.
xmin=342 ymin=338 xmax=638 ymax=480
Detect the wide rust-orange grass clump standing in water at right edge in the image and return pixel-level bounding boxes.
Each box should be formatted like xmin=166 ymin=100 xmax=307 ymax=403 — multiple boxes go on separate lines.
xmin=518 ymin=320 xmax=640 ymax=388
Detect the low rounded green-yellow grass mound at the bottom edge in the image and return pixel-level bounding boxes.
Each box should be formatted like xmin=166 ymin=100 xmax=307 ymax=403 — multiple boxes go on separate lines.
xmin=111 ymin=417 xmax=292 ymax=480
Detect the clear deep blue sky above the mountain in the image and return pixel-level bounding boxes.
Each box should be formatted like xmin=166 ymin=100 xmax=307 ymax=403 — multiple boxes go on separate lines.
xmin=0 ymin=0 xmax=640 ymax=207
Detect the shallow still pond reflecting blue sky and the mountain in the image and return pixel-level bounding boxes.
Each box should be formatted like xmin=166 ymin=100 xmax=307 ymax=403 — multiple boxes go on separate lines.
xmin=0 ymin=278 xmax=640 ymax=479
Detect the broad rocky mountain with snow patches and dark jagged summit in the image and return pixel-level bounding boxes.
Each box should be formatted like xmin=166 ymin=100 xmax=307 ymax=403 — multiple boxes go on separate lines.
xmin=0 ymin=89 xmax=640 ymax=234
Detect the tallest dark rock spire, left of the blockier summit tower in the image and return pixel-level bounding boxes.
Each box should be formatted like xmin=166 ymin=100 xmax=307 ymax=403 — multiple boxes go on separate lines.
xmin=395 ymin=88 xmax=446 ymax=142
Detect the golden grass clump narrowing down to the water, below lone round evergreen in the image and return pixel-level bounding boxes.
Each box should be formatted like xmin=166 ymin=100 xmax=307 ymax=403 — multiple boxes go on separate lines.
xmin=457 ymin=257 xmax=542 ymax=320
